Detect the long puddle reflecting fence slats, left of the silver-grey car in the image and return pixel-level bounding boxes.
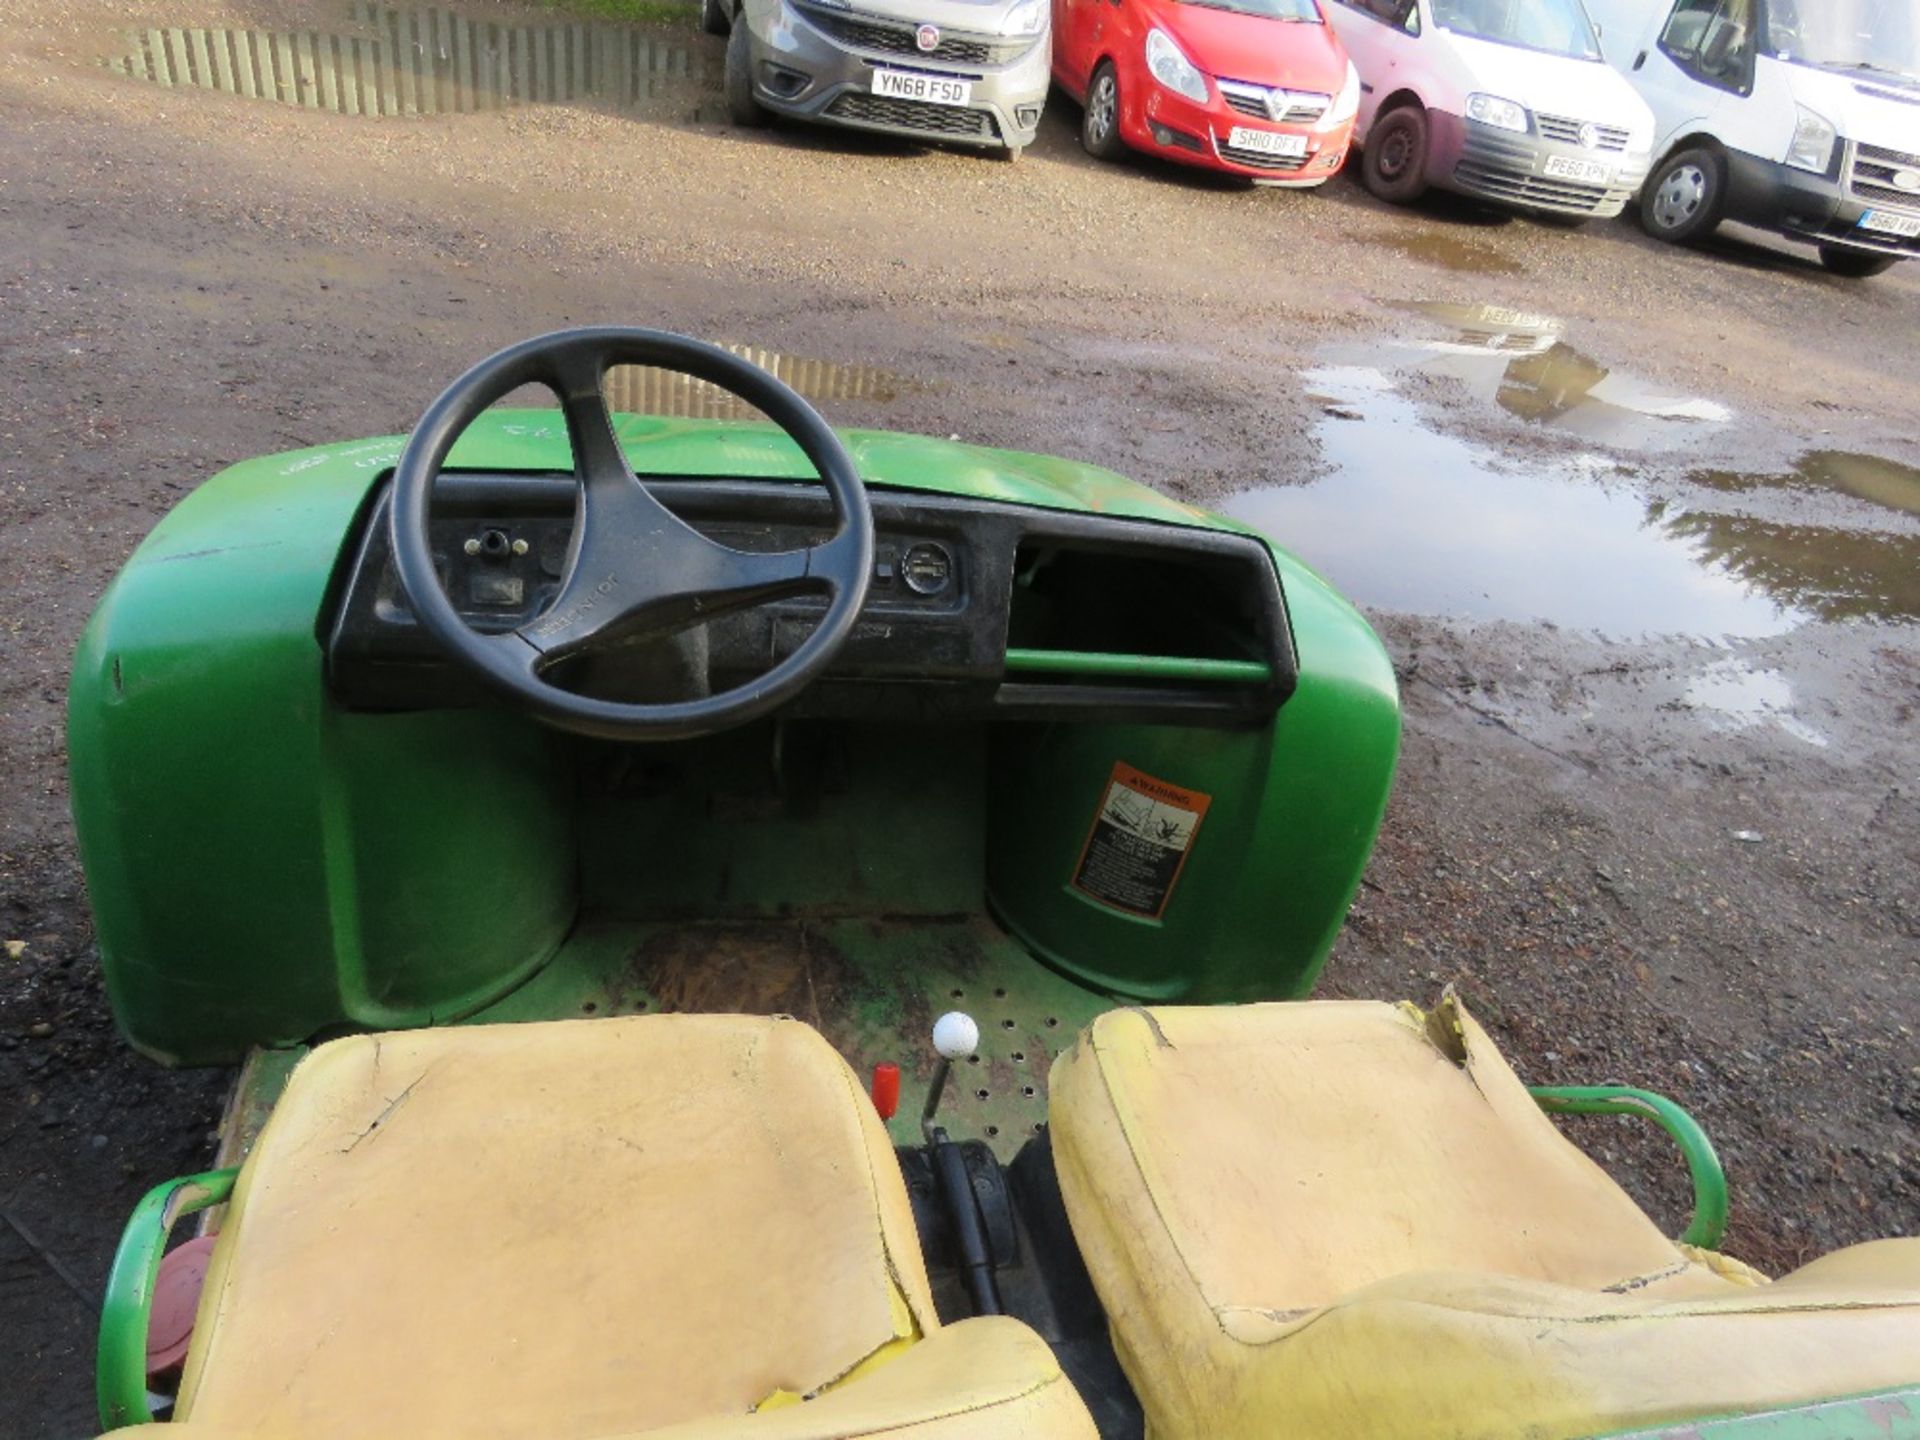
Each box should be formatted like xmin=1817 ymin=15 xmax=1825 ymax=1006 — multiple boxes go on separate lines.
xmin=102 ymin=0 xmax=708 ymax=119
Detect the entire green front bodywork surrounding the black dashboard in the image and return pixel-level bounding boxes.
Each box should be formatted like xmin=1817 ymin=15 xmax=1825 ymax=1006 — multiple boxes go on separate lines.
xmin=69 ymin=411 xmax=1398 ymax=1064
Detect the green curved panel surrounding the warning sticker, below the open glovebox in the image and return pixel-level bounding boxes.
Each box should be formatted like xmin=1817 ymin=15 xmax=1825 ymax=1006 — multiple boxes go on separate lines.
xmin=987 ymin=518 xmax=1400 ymax=1004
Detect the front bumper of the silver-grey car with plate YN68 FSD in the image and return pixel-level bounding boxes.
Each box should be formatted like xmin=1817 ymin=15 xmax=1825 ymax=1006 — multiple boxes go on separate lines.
xmin=747 ymin=0 xmax=1050 ymax=148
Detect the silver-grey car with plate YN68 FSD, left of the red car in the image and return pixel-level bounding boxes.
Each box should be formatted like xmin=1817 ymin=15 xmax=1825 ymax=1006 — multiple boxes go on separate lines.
xmin=703 ymin=0 xmax=1052 ymax=159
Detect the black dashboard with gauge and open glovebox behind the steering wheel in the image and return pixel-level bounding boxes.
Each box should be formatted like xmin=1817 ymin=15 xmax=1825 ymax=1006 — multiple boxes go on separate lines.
xmin=321 ymin=472 xmax=1298 ymax=724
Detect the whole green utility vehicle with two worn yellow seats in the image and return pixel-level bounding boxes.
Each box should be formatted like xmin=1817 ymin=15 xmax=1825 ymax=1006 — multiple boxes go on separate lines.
xmin=71 ymin=328 xmax=1920 ymax=1440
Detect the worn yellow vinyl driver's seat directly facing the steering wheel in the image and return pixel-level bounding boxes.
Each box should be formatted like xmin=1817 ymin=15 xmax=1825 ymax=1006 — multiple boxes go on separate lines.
xmin=177 ymin=1016 xmax=1079 ymax=1440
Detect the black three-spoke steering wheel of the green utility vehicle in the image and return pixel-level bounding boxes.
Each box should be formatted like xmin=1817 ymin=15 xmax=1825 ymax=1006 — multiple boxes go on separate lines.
xmin=390 ymin=326 xmax=874 ymax=739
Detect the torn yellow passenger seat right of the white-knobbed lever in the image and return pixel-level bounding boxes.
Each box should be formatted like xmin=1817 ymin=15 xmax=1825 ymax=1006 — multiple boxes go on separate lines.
xmin=1050 ymin=1000 xmax=1920 ymax=1440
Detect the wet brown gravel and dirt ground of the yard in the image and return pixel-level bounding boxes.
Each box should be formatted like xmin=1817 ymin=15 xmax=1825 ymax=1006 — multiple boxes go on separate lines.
xmin=0 ymin=0 xmax=1920 ymax=1436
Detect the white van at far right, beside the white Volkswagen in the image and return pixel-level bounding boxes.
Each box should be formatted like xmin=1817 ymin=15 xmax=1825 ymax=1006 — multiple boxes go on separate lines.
xmin=1588 ymin=0 xmax=1920 ymax=276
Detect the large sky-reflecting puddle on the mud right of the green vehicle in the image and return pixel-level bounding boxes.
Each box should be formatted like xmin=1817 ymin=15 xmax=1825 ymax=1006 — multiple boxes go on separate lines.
xmin=1225 ymin=365 xmax=1920 ymax=641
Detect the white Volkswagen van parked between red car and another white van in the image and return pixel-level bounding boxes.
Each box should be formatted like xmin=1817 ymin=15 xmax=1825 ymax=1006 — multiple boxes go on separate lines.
xmin=1327 ymin=0 xmax=1653 ymax=219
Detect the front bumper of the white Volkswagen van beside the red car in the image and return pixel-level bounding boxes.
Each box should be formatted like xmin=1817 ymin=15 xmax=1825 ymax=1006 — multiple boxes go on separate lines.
xmin=1427 ymin=109 xmax=1651 ymax=217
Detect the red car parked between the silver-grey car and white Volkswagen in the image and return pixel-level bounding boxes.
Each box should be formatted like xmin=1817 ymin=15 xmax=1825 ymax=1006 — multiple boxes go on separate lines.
xmin=1052 ymin=0 xmax=1359 ymax=188
